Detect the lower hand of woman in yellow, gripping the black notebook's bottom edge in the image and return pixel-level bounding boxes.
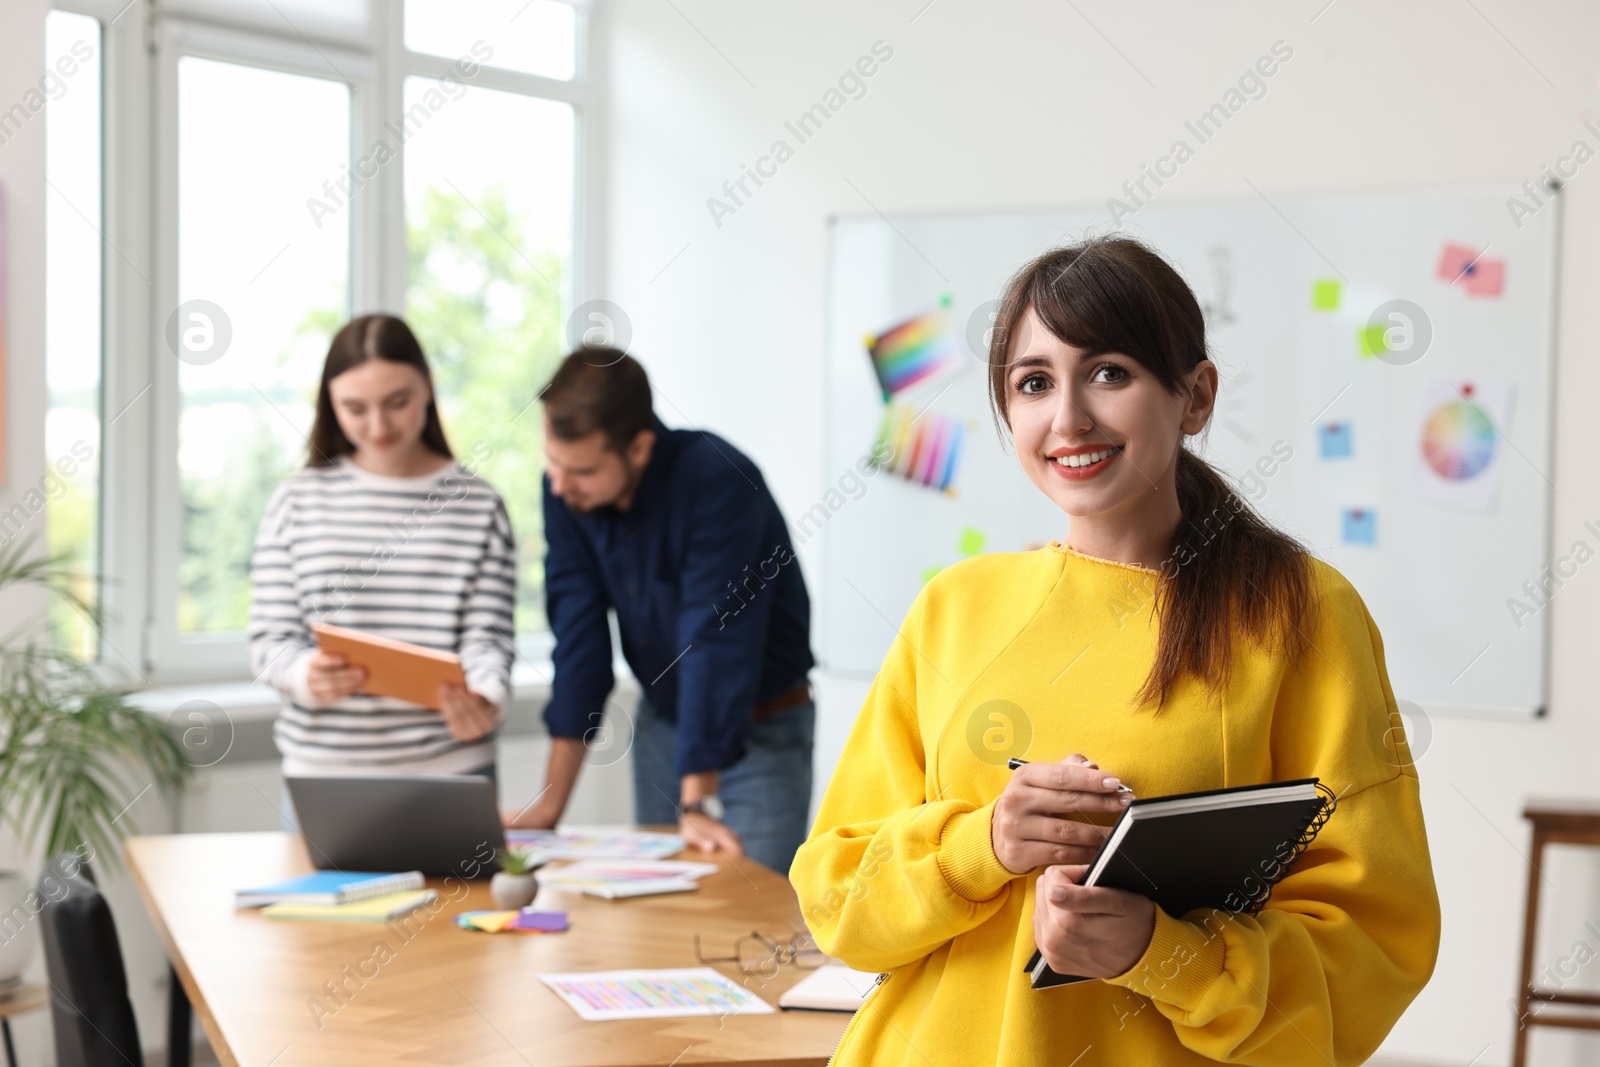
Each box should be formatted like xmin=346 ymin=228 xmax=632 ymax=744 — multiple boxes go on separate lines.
xmin=1034 ymin=864 xmax=1155 ymax=977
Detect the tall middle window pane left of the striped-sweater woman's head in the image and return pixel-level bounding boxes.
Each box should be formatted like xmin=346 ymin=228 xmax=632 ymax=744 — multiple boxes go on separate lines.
xmin=173 ymin=56 xmax=350 ymax=635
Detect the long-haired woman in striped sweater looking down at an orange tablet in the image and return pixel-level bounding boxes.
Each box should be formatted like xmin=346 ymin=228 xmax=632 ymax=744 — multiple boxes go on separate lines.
xmin=250 ymin=315 xmax=517 ymax=777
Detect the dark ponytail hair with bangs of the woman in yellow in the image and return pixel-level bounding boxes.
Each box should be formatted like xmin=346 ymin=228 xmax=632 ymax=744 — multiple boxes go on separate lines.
xmin=989 ymin=237 xmax=1315 ymax=707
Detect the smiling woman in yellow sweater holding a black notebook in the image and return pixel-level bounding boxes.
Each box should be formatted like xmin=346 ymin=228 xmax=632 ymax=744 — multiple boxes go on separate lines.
xmin=789 ymin=238 xmax=1438 ymax=1067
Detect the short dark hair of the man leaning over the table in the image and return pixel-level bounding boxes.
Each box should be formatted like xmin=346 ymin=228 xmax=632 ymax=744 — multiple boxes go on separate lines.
xmin=542 ymin=346 xmax=654 ymax=454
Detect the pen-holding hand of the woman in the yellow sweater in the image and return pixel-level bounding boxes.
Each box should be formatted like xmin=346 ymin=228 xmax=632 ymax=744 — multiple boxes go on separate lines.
xmin=989 ymin=753 xmax=1133 ymax=875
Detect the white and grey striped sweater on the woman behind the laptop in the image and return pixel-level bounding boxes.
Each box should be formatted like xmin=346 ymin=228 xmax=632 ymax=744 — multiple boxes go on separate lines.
xmin=250 ymin=456 xmax=517 ymax=774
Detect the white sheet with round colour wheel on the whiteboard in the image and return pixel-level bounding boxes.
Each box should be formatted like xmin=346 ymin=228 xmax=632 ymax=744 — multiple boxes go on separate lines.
xmin=1411 ymin=378 xmax=1514 ymax=512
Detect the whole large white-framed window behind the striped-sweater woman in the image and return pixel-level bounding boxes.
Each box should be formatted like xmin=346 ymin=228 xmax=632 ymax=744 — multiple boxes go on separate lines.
xmin=62 ymin=0 xmax=592 ymax=683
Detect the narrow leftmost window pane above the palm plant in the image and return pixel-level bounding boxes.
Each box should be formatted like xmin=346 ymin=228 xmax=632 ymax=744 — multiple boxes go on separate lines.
xmin=44 ymin=11 xmax=104 ymax=659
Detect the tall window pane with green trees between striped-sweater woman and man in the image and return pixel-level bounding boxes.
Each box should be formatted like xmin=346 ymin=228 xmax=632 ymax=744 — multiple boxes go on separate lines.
xmin=405 ymin=78 xmax=573 ymax=630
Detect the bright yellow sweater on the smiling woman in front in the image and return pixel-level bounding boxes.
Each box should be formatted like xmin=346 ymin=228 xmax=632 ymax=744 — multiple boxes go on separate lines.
xmin=789 ymin=542 xmax=1438 ymax=1067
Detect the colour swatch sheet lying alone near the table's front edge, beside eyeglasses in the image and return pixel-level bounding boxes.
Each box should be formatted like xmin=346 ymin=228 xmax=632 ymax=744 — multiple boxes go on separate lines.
xmin=539 ymin=966 xmax=774 ymax=1022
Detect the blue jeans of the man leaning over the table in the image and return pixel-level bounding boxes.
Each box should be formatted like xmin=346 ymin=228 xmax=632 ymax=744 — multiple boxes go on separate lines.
xmin=632 ymin=696 xmax=816 ymax=875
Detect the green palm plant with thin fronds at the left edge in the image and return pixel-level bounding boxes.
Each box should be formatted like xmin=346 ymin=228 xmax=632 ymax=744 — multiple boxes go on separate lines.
xmin=0 ymin=544 xmax=194 ymax=867
